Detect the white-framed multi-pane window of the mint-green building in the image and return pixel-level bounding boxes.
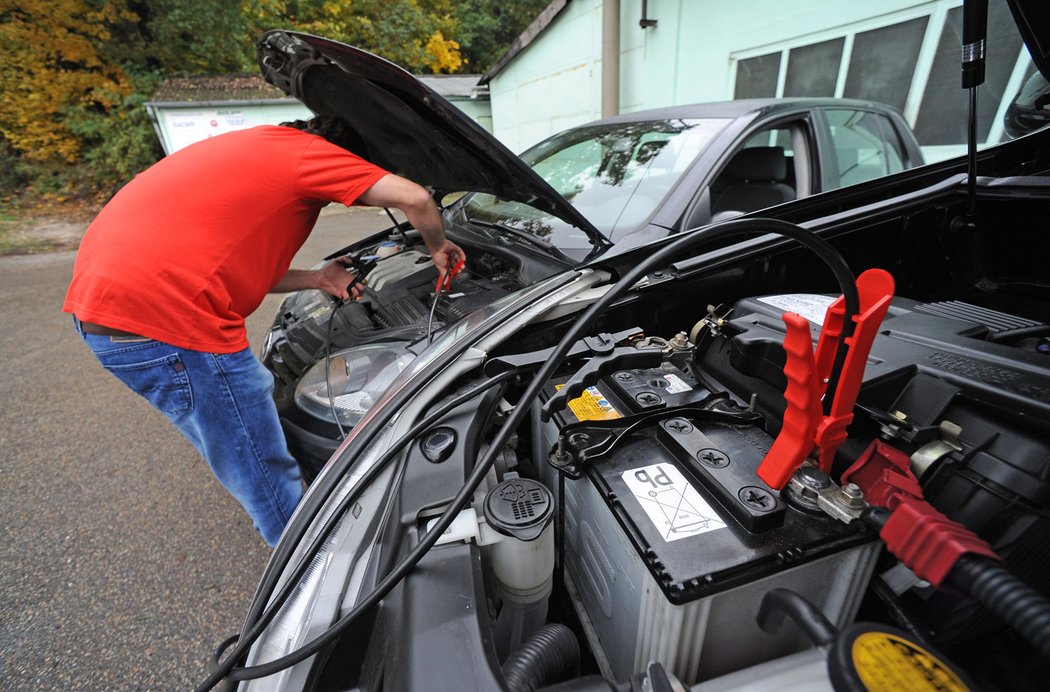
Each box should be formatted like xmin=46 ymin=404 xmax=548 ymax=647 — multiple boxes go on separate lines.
xmin=731 ymin=0 xmax=1031 ymax=155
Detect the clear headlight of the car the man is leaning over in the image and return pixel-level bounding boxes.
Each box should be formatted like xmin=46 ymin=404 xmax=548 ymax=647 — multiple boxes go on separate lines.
xmin=295 ymin=341 xmax=416 ymax=427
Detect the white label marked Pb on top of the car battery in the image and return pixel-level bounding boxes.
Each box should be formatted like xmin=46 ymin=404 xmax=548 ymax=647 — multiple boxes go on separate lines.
xmin=621 ymin=464 xmax=726 ymax=542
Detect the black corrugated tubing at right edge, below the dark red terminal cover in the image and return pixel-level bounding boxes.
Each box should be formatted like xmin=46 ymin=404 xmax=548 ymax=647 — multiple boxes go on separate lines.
xmin=950 ymin=554 xmax=1050 ymax=658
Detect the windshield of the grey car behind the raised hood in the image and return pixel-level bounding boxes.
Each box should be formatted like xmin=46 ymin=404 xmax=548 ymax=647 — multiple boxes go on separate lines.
xmin=463 ymin=118 xmax=730 ymax=258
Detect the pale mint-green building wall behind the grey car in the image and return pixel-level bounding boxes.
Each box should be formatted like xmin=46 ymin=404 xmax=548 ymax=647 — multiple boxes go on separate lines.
xmin=488 ymin=0 xmax=1031 ymax=161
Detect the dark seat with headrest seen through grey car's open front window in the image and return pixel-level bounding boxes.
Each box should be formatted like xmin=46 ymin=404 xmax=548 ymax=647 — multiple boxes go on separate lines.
xmin=712 ymin=147 xmax=795 ymax=218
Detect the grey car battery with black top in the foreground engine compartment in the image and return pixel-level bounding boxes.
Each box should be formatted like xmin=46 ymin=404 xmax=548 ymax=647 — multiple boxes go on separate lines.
xmin=533 ymin=361 xmax=879 ymax=685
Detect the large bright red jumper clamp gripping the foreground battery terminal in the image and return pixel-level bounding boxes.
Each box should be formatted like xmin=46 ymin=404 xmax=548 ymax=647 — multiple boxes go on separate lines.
xmin=758 ymin=269 xmax=894 ymax=490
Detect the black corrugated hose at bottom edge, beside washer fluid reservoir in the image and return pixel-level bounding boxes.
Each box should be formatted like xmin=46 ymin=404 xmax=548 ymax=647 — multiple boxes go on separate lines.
xmin=503 ymin=623 xmax=580 ymax=692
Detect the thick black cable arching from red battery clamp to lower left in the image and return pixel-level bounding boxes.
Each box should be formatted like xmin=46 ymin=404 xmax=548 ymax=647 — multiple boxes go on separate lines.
xmin=215 ymin=218 xmax=860 ymax=690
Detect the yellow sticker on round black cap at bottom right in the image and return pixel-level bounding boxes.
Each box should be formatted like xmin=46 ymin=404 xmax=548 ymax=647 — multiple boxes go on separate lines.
xmin=853 ymin=632 xmax=969 ymax=692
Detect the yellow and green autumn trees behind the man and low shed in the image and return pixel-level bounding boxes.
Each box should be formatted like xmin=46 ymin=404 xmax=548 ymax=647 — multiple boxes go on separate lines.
xmin=0 ymin=0 xmax=547 ymax=201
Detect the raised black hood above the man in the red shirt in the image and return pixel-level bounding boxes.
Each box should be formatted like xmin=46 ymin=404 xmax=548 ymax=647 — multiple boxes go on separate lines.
xmin=258 ymin=30 xmax=611 ymax=254
